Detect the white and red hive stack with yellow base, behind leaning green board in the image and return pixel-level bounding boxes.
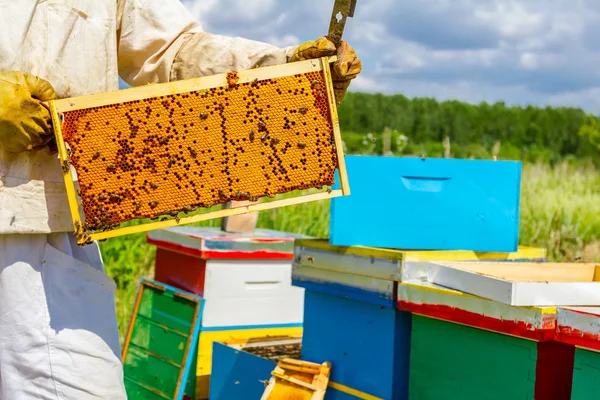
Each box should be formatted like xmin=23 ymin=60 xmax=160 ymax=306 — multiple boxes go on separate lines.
xmin=137 ymin=227 xmax=304 ymax=399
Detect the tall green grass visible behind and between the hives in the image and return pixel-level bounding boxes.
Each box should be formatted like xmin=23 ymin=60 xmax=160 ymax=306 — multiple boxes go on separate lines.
xmin=101 ymin=163 xmax=600 ymax=344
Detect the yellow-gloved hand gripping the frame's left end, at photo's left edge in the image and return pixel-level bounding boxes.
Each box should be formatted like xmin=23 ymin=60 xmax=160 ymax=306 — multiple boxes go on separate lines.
xmin=0 ymin=71 xmax=56 ymax=153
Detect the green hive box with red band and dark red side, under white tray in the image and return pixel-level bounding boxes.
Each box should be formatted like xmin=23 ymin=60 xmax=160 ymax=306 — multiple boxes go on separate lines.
xmin=398 ymin=281 xmax=576 ymax=400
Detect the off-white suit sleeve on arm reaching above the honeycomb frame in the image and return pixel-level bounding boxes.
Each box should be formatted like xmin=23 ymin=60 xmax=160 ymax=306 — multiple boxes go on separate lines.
xmin=117 ymin=0 xmax=294 ymax=86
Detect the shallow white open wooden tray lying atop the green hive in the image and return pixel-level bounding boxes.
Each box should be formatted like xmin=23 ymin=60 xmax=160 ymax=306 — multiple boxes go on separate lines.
xmin=428 ymin=262 xmax=600 ymax=306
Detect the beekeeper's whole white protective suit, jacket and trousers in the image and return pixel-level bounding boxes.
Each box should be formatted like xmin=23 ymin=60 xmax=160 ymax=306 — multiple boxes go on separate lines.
xmin=0 ymin=0 xmax=293 ymax=400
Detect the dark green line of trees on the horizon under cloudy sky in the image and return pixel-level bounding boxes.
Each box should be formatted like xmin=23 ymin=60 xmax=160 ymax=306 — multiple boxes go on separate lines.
xmin=339 ymin=92 xmax=600 ymax=161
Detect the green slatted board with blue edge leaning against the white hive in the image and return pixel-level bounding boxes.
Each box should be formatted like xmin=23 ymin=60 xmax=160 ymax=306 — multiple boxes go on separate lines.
xmin=122 ymin=279 xmax=203 ymax=400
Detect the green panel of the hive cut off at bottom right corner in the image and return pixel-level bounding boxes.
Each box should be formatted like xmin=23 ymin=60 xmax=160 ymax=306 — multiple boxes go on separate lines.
xmin=571 ymin=348 xmax=600 ymax=400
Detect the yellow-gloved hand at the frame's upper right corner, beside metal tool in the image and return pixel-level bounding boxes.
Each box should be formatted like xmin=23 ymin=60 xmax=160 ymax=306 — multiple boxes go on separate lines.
xmin=290 ymin=37 xmax=362 ymax=106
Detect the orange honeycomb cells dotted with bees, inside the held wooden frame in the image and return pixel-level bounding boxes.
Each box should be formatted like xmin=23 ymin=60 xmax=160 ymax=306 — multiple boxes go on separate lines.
xmin=62 ymin=71 xmax=338 ymax=231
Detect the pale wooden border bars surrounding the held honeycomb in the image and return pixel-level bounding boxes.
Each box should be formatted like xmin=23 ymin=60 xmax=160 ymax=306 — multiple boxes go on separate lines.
xmin=48 ymin=56 xmax=350 ymax=245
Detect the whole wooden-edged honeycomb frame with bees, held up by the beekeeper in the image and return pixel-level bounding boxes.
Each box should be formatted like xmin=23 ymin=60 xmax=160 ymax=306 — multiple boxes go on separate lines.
xmin=49 ymin=58 xmax=349 ymax=244
